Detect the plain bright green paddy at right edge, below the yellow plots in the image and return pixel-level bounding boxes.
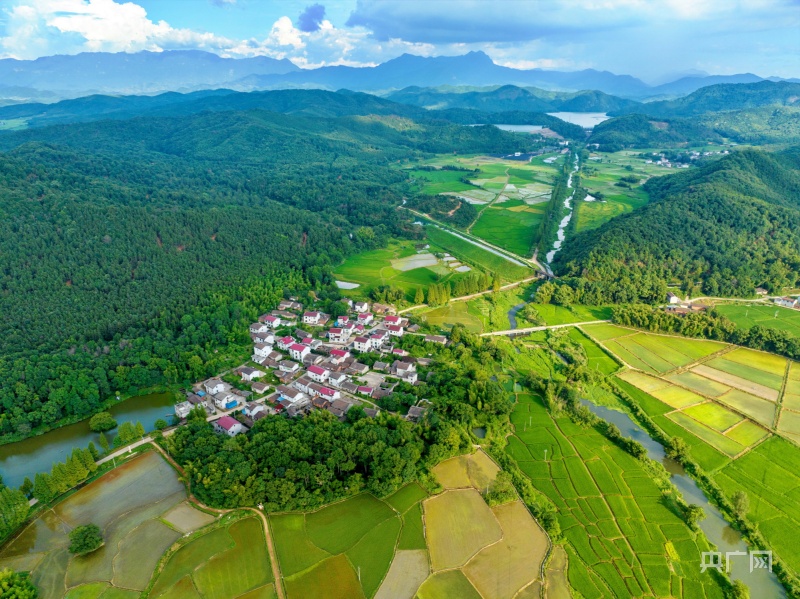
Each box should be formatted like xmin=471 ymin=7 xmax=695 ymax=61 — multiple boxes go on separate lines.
xmin=714 ymin=436 xmax=800 ymax=575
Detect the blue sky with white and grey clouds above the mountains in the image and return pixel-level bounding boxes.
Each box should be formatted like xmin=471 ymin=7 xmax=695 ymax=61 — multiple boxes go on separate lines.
xmin=0 ymin=0 xmax=800 ymax=82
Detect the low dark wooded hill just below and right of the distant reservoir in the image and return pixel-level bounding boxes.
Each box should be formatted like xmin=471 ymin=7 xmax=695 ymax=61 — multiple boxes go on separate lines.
xmin=588 ymin=114 xmax=722 ymax=151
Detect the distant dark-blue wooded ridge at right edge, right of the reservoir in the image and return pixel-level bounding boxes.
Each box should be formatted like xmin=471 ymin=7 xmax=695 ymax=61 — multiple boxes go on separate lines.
xmin=613 ymin=81 xmax=800 ymax=117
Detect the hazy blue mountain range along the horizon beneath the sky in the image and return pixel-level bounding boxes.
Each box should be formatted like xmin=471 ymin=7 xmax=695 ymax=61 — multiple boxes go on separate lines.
xmin=0 ymin=50 xmax=795 ymax=102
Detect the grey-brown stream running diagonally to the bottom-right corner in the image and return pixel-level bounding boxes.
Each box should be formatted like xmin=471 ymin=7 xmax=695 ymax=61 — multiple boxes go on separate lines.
xmin=583 ymin=399 xmax=786 ymax=599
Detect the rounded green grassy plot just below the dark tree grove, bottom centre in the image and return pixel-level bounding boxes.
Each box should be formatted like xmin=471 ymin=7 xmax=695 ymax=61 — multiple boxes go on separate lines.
xmin=306 ymin=493 xmax=394 ymax=555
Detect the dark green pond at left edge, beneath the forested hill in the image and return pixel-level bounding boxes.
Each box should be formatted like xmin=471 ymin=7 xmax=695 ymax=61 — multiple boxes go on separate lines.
xmin=0 ymin=393 xmax=174 ymax=487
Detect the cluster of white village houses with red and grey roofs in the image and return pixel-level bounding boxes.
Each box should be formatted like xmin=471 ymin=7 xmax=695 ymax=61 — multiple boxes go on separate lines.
xmin=175 ymin=298 xmax=448 ymax=437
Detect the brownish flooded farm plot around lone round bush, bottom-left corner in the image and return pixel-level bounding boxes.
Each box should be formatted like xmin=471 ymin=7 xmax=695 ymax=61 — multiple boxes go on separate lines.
xmin=0 ymin=452 xmax=186 ymax=599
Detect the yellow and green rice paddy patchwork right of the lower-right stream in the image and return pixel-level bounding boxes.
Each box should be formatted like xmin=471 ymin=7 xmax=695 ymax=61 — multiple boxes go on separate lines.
xmin=598 ymin=327 xmax=800 ymax=574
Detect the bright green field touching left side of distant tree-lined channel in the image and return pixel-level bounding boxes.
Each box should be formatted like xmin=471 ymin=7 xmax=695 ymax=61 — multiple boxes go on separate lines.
xmin=470 ymin=200 xmax=545 ymax=257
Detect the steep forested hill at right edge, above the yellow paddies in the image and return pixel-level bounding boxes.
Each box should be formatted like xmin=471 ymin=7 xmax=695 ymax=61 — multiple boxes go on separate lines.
xmin=556 ymin=149 xmax=800 ymax=304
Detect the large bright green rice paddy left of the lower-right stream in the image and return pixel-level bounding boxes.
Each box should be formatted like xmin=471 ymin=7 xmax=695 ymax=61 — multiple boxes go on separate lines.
xmin=506 ymin=393 xmax=723 ymax=599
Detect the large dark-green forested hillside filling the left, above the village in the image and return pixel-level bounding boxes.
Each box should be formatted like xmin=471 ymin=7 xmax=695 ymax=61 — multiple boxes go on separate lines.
xmin=0 ymin=105 xmax=533 ymax=438
